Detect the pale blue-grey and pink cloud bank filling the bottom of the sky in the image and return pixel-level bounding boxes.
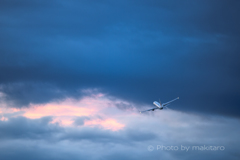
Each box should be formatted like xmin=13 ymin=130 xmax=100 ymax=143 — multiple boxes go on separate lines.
xmin=0 ymin=94 xmax=240 ymax=160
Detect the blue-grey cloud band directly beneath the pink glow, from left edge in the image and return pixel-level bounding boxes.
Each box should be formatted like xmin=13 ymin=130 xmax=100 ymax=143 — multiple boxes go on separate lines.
xmin=0 ymin=116 xmax=157 ymax=145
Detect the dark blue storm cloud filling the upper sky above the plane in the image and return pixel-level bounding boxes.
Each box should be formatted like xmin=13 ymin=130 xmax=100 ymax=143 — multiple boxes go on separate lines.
xmin=0 ymin=0 xmax=240 ymax=116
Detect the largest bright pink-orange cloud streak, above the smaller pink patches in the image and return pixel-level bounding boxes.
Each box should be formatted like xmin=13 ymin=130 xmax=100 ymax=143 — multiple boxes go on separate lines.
xmin=22 ymin=97 xmax=109 ymax=119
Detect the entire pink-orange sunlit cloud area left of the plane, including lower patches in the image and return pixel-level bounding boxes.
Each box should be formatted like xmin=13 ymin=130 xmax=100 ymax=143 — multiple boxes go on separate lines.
xmin=0 ymin=93 xmax=125 ymax=131
